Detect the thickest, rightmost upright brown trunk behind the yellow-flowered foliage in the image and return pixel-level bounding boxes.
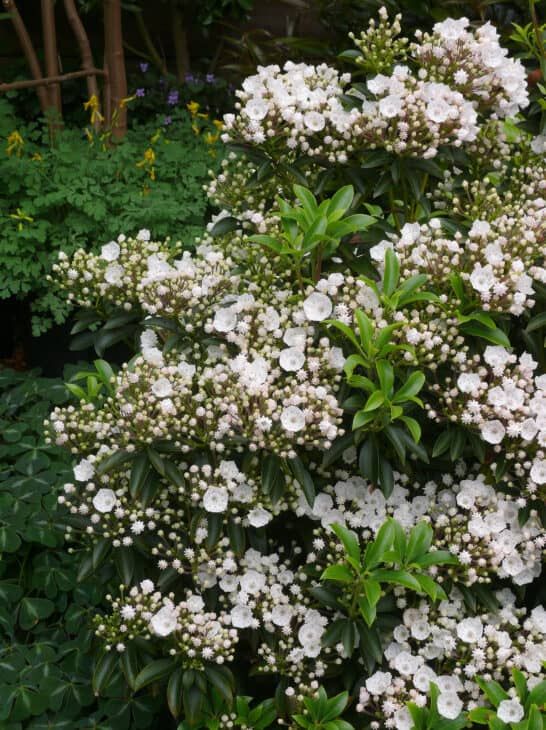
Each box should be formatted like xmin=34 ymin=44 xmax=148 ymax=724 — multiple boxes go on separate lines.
xmin=104 ymin=0 xmax=127 ymax=137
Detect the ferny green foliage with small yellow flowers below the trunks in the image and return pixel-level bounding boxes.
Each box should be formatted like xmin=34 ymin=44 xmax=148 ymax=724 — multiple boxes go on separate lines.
xmin=0 ymin=99 xmax=214 ymax=334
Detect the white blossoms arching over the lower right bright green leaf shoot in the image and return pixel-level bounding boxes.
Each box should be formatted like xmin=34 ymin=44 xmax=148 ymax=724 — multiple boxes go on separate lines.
xmin=295 ymin=464 xmax=546 ymax=585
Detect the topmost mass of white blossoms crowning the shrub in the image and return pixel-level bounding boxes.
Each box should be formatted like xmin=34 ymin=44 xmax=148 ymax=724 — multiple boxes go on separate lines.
xmin=223 ymin=10 xmax=528 ymax=163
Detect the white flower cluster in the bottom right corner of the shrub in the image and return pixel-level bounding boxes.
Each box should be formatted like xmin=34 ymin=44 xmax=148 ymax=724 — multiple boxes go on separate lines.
xmin=358 ymin=589 xmax=546 ymax=730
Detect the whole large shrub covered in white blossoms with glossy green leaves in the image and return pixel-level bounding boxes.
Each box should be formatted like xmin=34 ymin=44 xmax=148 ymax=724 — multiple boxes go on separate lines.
xmin=35 ymin=5 xmax=546 ymax=730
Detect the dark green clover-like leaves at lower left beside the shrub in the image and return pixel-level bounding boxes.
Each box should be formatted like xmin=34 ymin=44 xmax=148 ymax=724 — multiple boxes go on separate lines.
xmin=0 ymin=370 xmax=164 ymax=730
